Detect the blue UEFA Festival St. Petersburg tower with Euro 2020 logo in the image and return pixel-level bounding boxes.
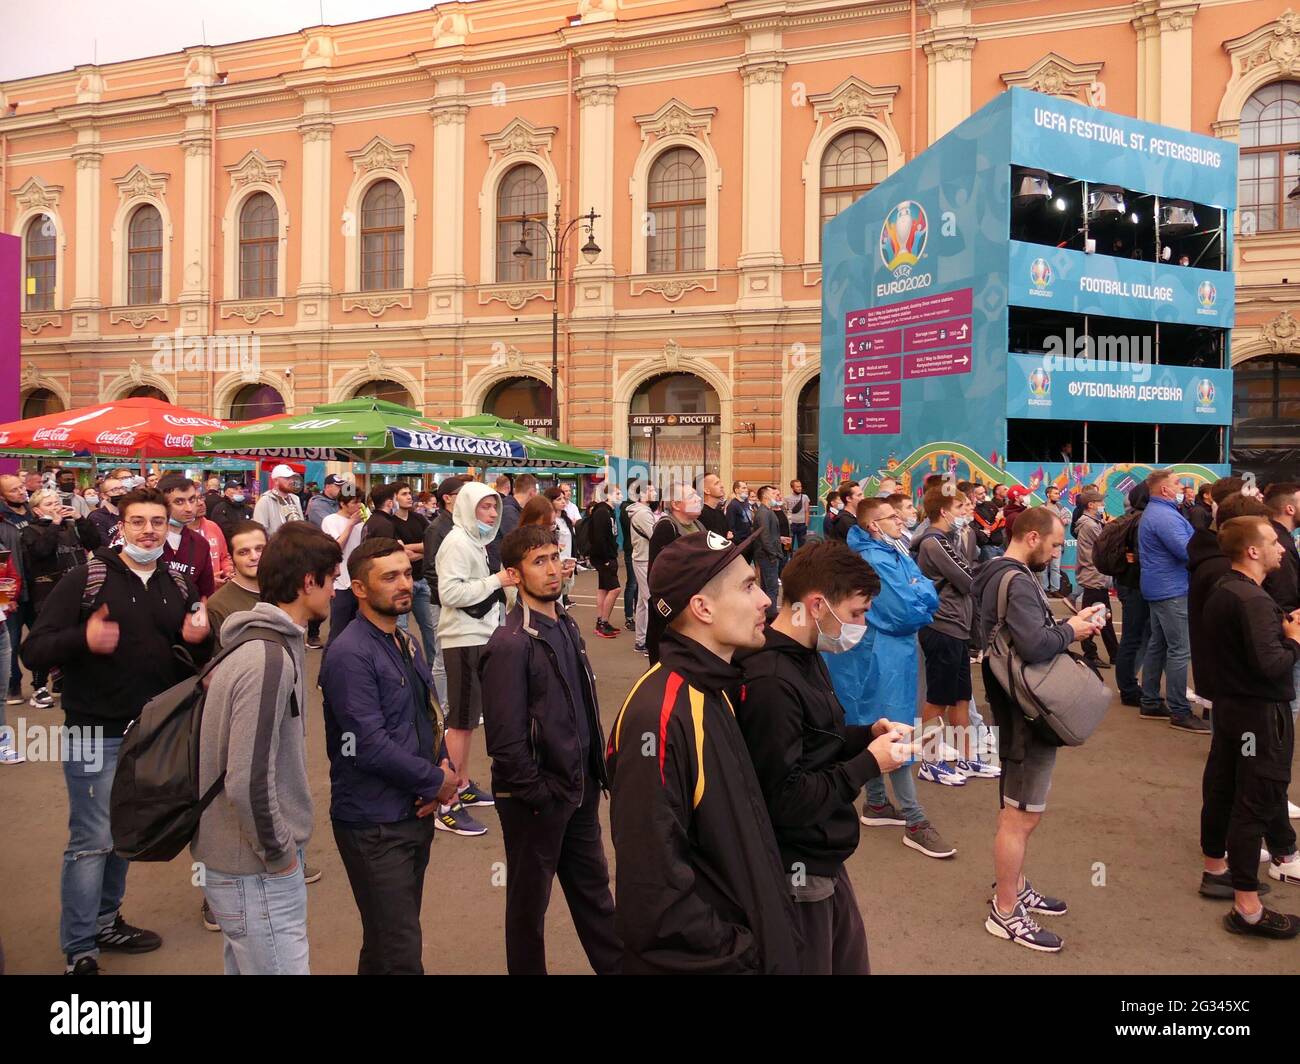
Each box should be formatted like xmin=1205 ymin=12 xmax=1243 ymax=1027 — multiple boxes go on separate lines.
xmin=819 ymin=88 xmax=1238 ymax=522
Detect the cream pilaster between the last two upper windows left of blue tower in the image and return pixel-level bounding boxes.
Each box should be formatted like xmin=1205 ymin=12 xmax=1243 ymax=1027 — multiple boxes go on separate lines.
xmin=736 ymin=21 xmax=785 ymax=310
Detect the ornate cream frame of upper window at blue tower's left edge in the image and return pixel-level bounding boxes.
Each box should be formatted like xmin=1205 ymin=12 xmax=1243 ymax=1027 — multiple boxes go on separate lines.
xmin=802 ymin=75 xmax=905 ymax=267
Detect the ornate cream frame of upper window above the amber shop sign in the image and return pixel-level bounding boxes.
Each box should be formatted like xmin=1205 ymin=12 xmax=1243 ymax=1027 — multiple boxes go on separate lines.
xmin=629 ymin=96 xmax=723 ymax=275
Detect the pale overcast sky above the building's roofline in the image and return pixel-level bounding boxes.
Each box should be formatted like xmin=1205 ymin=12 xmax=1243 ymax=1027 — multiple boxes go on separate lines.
xmin=0 ymin=0 xmax=433 ymax=81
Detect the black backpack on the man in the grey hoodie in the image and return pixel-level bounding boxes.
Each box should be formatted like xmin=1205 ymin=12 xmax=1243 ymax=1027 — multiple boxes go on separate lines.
xmin=109 ymin=628 xmax=299 ymax=861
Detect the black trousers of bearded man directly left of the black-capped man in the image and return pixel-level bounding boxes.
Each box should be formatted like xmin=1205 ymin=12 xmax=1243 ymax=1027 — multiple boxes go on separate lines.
xmin=497 ymin=778 xmax=623 ymax=976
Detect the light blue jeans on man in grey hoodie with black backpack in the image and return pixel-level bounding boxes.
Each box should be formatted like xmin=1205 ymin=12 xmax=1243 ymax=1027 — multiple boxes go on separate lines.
xmin=203 ymin=851 xmax=311 ymax=976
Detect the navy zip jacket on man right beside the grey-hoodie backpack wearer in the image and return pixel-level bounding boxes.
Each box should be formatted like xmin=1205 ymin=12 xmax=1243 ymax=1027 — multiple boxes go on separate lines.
xmin=320 ymin=614 xmax=447 ymax=825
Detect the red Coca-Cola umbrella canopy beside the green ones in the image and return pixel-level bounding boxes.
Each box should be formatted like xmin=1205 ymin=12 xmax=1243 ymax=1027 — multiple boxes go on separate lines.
xmin=0 ymin=398 xmax=234 ymax=459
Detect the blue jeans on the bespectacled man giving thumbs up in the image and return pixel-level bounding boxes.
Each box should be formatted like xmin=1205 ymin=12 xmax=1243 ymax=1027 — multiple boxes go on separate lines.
xmin=59 ymin=730 xmax=129 ymax=961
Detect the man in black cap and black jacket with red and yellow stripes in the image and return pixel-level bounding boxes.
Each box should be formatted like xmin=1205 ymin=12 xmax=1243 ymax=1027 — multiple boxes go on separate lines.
xmin=608 ymin=532 xmax=800 ymax=974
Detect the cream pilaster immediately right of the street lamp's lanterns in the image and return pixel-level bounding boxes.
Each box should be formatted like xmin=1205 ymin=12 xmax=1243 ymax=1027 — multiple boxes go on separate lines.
xmin=574 ymin=51 xmax=619 ymax=317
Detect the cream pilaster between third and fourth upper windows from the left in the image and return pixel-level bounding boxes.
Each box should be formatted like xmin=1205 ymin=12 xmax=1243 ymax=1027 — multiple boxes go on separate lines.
xmin=298 ymin=92 xmax=332 ymax=328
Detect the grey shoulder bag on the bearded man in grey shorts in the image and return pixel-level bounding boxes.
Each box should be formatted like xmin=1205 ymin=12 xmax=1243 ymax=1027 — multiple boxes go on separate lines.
xmin=988 ymin=568 xmax=1112 ymax=747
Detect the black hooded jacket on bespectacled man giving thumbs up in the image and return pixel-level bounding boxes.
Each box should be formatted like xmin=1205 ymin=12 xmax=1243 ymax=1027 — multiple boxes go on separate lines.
xmin=21 ymin=548 xmax=198 ymax=739
